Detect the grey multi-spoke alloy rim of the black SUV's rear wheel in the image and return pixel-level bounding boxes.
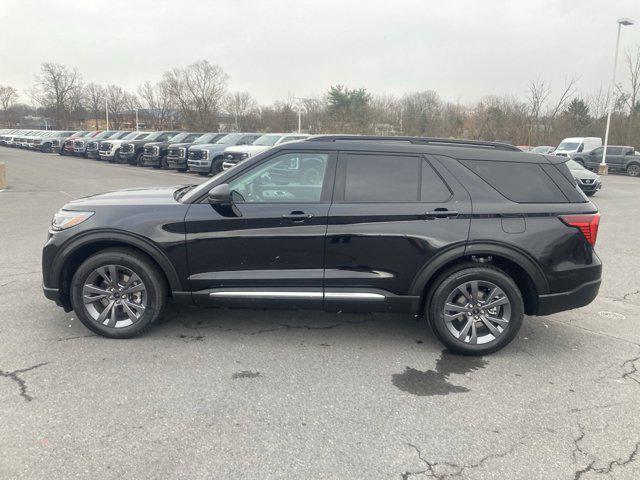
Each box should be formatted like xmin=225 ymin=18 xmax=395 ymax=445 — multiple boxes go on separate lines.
xmin=443 ymin=280 xmax=511 ymax=345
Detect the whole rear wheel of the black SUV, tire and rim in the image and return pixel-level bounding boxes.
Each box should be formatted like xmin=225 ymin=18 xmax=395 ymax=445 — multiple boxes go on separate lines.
xmin=427 ymin=264 xmax=524 ymax=355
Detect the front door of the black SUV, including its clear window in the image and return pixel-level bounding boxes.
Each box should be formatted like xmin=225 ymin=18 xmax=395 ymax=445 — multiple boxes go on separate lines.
xmin=186 ymin=150 xmax=336 ymax=308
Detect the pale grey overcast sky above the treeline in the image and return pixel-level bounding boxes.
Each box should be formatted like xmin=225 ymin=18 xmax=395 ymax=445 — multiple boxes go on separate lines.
xmin=0 ymin=0 xmax=640 ymax=103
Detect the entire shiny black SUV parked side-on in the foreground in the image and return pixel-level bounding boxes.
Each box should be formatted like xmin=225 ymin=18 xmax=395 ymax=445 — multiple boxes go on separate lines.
xmin=42 ymin=136 xmax=602 ymax=355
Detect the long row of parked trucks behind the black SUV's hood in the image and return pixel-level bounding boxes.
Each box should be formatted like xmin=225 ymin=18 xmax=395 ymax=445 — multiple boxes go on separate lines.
xmin=0 ymin=130 xmax=309 ymax=175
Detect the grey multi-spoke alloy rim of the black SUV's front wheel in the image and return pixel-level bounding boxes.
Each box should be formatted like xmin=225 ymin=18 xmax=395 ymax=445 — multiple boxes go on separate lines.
xmin=82 ymin=265 xmax=148 ymax=328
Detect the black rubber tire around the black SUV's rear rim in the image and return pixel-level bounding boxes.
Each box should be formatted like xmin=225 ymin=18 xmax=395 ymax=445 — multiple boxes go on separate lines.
xmin=426 ymin=263 xmax=524 ymax=355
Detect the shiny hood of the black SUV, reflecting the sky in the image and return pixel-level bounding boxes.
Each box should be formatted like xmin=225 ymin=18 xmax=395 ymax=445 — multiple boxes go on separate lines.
xmin=63 ymin=185 xmax=183 ymax=210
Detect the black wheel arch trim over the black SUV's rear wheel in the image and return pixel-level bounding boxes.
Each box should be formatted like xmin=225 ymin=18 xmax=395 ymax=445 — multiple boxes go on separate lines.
xmin=409 ymin=242 xmax=549 ymax=315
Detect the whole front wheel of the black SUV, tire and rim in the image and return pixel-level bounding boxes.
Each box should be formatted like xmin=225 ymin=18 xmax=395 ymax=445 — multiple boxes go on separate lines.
xmin=71 ymin=249 xmax=167 ymax=338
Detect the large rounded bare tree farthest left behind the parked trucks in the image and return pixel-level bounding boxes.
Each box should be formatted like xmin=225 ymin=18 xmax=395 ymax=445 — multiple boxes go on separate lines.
xmin=32 ymin=63 xmax=82 ymax=125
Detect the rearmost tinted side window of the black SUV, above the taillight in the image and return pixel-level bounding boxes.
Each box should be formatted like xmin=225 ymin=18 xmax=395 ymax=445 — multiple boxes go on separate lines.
xmin=461 ymin=160 xmax=567 ymax=203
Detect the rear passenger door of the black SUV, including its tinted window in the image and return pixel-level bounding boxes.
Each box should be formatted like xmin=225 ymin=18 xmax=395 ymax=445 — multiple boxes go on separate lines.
xmin=325 ymin=151 xmax=471 ymax=311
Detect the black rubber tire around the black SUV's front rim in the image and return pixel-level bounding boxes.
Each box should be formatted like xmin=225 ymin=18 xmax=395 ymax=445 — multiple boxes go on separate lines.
xmin=71 ymin=248 xmax=167 ymax=338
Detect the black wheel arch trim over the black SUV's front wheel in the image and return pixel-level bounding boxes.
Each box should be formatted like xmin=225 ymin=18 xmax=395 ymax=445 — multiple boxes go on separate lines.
xmin=50 ymin=231 xmax=183 ymax=306
